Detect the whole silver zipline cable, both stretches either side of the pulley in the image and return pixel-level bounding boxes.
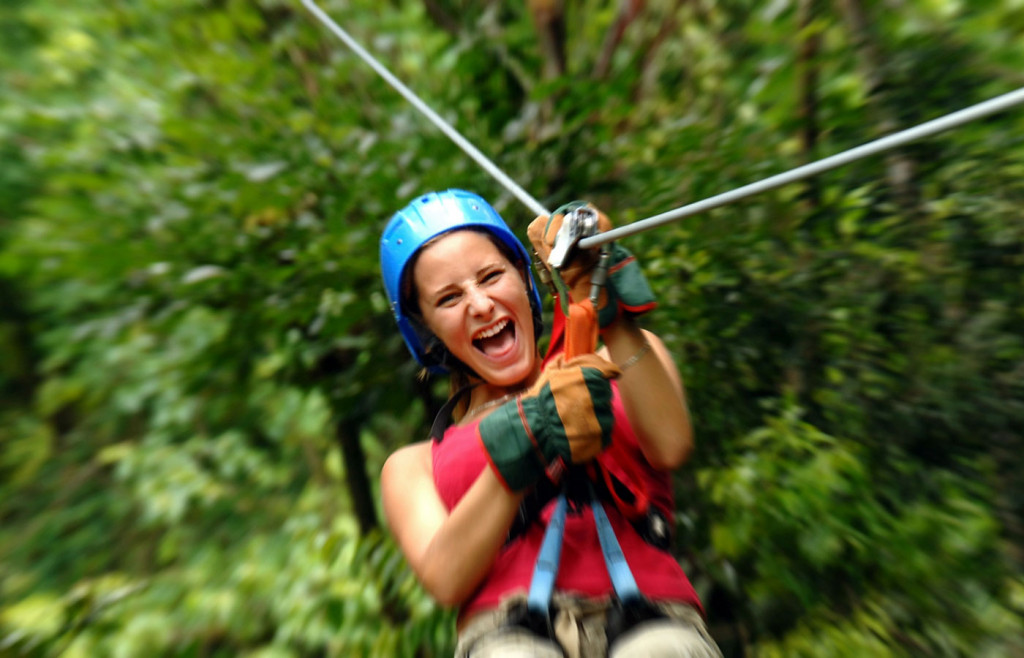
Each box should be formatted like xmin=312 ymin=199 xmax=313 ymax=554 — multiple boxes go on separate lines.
xmin=302 ymin=0 xmax=1024 ymax=249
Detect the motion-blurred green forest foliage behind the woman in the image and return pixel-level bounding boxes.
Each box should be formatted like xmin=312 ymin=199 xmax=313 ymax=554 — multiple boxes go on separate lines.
xmin=0 ymin=0 xmax=1024 ymax=658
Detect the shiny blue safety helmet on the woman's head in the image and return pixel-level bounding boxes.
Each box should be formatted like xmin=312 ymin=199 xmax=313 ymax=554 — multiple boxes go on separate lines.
xmin=381 ymin=189 xmax=543 ymax=372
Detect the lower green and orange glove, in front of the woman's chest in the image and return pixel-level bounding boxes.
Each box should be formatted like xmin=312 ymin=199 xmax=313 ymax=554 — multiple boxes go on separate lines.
xmin=478 ymin=354 xmax=620 ymax=491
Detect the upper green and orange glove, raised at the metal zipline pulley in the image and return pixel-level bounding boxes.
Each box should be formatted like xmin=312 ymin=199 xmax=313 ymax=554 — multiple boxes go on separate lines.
xmin=526 ymin=201 xmax=657 ymax=328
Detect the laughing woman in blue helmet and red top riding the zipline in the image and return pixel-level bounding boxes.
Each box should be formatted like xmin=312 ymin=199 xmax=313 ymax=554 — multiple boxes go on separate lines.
xmin=381 ymin=190 xmax=720 ymax=658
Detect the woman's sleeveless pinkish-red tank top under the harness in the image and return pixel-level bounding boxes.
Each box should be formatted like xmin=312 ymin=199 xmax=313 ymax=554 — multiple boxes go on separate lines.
xmin=431 ymin=382 xmax=702 ymax=619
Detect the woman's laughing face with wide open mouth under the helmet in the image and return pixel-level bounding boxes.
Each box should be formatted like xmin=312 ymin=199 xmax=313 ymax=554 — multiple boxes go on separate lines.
xmin=413 ymin=230 xmax=537 ymax=386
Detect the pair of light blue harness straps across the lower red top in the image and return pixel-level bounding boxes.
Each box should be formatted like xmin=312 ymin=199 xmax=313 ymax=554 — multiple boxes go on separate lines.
xmin=526 ymin=488 xmax=642 ymax=617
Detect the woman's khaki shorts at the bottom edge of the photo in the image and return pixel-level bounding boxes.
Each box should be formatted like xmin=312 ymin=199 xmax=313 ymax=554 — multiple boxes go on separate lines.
xmin=455 ymin=594 xmax=722 ymax=658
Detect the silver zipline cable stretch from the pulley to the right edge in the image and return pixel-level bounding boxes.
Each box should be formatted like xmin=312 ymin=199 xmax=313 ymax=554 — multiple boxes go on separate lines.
xmin=580 ymin=87 xmax=1024 ymax=249
